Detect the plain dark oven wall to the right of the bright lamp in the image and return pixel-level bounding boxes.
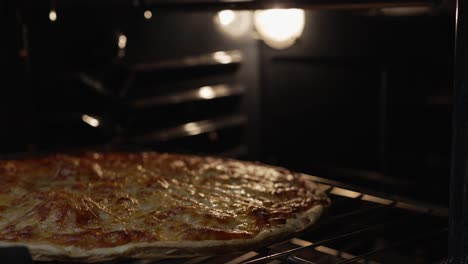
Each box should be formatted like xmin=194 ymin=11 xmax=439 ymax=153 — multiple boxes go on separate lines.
xmin=260 ymin=11 xmax=454 ymax=202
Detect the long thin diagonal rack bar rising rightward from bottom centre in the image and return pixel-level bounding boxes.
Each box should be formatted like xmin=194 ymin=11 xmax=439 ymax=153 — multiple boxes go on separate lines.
xmin=243 ymin=217 xmax=414 ymax=264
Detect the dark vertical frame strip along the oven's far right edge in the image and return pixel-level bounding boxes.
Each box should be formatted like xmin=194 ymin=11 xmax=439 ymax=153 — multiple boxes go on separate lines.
xmin=448 ymin=0 xmax=468 ymax=264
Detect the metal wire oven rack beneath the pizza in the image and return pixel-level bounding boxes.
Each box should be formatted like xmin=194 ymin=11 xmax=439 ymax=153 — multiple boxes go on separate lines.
xmin=7 ymin=176 xmax=448 ymax=264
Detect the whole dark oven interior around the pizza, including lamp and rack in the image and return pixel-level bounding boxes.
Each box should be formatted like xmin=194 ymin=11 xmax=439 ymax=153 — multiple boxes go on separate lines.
xmin=0 ymin=1 xmax=455 ymax=263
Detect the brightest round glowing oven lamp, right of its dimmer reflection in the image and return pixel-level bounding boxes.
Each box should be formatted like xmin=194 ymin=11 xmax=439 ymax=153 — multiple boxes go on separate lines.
xmin=254 ymin=9 xmax=305 ymax=49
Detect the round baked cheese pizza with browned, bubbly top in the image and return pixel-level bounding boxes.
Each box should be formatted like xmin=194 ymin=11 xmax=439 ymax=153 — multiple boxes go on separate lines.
xmin=0 ymin=152 xmax=329 ymax=262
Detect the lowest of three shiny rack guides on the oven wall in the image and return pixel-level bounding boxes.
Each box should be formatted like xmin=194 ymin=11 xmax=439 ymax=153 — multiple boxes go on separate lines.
xmin=133 ymin=115 xmax=247 ymax=143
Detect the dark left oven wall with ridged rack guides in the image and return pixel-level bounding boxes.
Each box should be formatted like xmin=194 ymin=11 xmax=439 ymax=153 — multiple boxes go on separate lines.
xmin=1 ymin=1 xmax=259 ymax=159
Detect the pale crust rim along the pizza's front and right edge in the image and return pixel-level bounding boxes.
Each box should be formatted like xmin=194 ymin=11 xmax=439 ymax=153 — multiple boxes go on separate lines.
xmin=0 ymin=174 xmax=328 ymax=263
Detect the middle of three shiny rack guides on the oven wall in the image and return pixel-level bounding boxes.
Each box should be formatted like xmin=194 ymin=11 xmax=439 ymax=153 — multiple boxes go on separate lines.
xmin=131 ymin=84 xmax=245 ymax=108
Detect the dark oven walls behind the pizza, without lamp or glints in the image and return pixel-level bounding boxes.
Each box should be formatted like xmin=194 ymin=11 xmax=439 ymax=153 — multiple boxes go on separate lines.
xmin=0 ymin=1 xmax=454 ymax=204
